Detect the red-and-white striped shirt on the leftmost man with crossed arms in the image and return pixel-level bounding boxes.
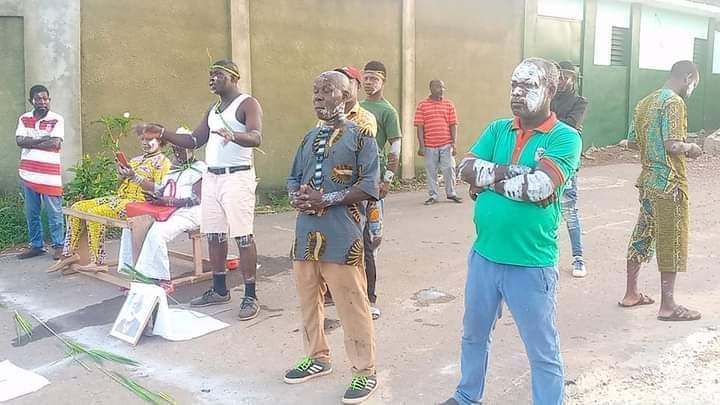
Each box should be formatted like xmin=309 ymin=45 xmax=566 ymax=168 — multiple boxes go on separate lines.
xmin=15 ymin=111 xmax=65 ymax=196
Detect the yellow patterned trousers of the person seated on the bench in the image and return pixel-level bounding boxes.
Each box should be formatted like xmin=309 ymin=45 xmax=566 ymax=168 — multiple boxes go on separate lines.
xmin=63 ymin=196 xmax=134 ymax=264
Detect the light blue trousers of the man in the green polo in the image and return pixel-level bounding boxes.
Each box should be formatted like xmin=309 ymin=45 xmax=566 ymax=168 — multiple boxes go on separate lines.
xmin=454 ymin=250 xmax=564 ymax=405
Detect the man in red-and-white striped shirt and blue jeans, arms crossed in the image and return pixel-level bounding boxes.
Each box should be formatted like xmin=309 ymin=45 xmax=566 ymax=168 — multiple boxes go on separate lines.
xmin=15 ymin=84 xmax=65 ymax=260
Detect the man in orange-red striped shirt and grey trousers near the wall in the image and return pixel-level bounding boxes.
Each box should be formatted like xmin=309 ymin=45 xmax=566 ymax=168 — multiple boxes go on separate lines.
xmin=415 ymin=80 xmax=462 ymax=205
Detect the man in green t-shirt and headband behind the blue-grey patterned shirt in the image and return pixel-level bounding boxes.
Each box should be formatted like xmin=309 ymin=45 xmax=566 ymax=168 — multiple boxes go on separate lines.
xmin=360 ymin=61 xmax=401 ymax=319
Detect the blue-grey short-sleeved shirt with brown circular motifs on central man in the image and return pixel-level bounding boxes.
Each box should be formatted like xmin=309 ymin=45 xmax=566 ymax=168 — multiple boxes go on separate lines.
xmin=288 ymin=121 xmax=380 ymax=266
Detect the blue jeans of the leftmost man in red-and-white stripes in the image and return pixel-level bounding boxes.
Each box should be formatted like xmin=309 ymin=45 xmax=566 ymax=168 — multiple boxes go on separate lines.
xmin=22 ymin=184 xmax=65 ymax=248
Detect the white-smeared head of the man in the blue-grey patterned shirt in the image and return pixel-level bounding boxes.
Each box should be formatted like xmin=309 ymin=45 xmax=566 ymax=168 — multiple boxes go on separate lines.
xmin=313 ymin=71 xmax=352 ymax=121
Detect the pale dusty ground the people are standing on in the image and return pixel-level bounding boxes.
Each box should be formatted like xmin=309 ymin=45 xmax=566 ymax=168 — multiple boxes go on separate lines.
xmin=0 ymin=155 xmax=720 ymax=405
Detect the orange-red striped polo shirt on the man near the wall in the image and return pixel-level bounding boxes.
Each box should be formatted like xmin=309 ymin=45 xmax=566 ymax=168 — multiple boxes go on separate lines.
xmin=415 ymin=97 xmax=457 ymax=148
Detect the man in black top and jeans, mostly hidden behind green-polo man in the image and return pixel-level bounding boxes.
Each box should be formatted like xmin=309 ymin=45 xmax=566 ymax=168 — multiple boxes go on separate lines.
xmin=550 ymin=61 xmax=588 ymax=278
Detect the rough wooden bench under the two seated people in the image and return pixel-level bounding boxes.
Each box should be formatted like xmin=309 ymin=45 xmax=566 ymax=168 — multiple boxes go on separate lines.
xmin=63 ymin=208 xmax=212 ymax=288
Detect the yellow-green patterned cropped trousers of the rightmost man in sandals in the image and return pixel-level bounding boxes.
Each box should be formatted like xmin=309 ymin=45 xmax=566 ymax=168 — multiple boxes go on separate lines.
xmin=627 ymin=189 xmax=689 ymax=272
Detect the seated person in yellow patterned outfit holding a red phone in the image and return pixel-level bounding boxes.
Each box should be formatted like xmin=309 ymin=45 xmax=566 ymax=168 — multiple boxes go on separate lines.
xmin=48 ymin=127 xmax=170 ymax=272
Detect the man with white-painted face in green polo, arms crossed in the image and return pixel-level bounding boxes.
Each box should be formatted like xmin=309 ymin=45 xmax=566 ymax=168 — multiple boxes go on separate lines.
xmin=444 ymin=58 xmax=581 ymax=405
